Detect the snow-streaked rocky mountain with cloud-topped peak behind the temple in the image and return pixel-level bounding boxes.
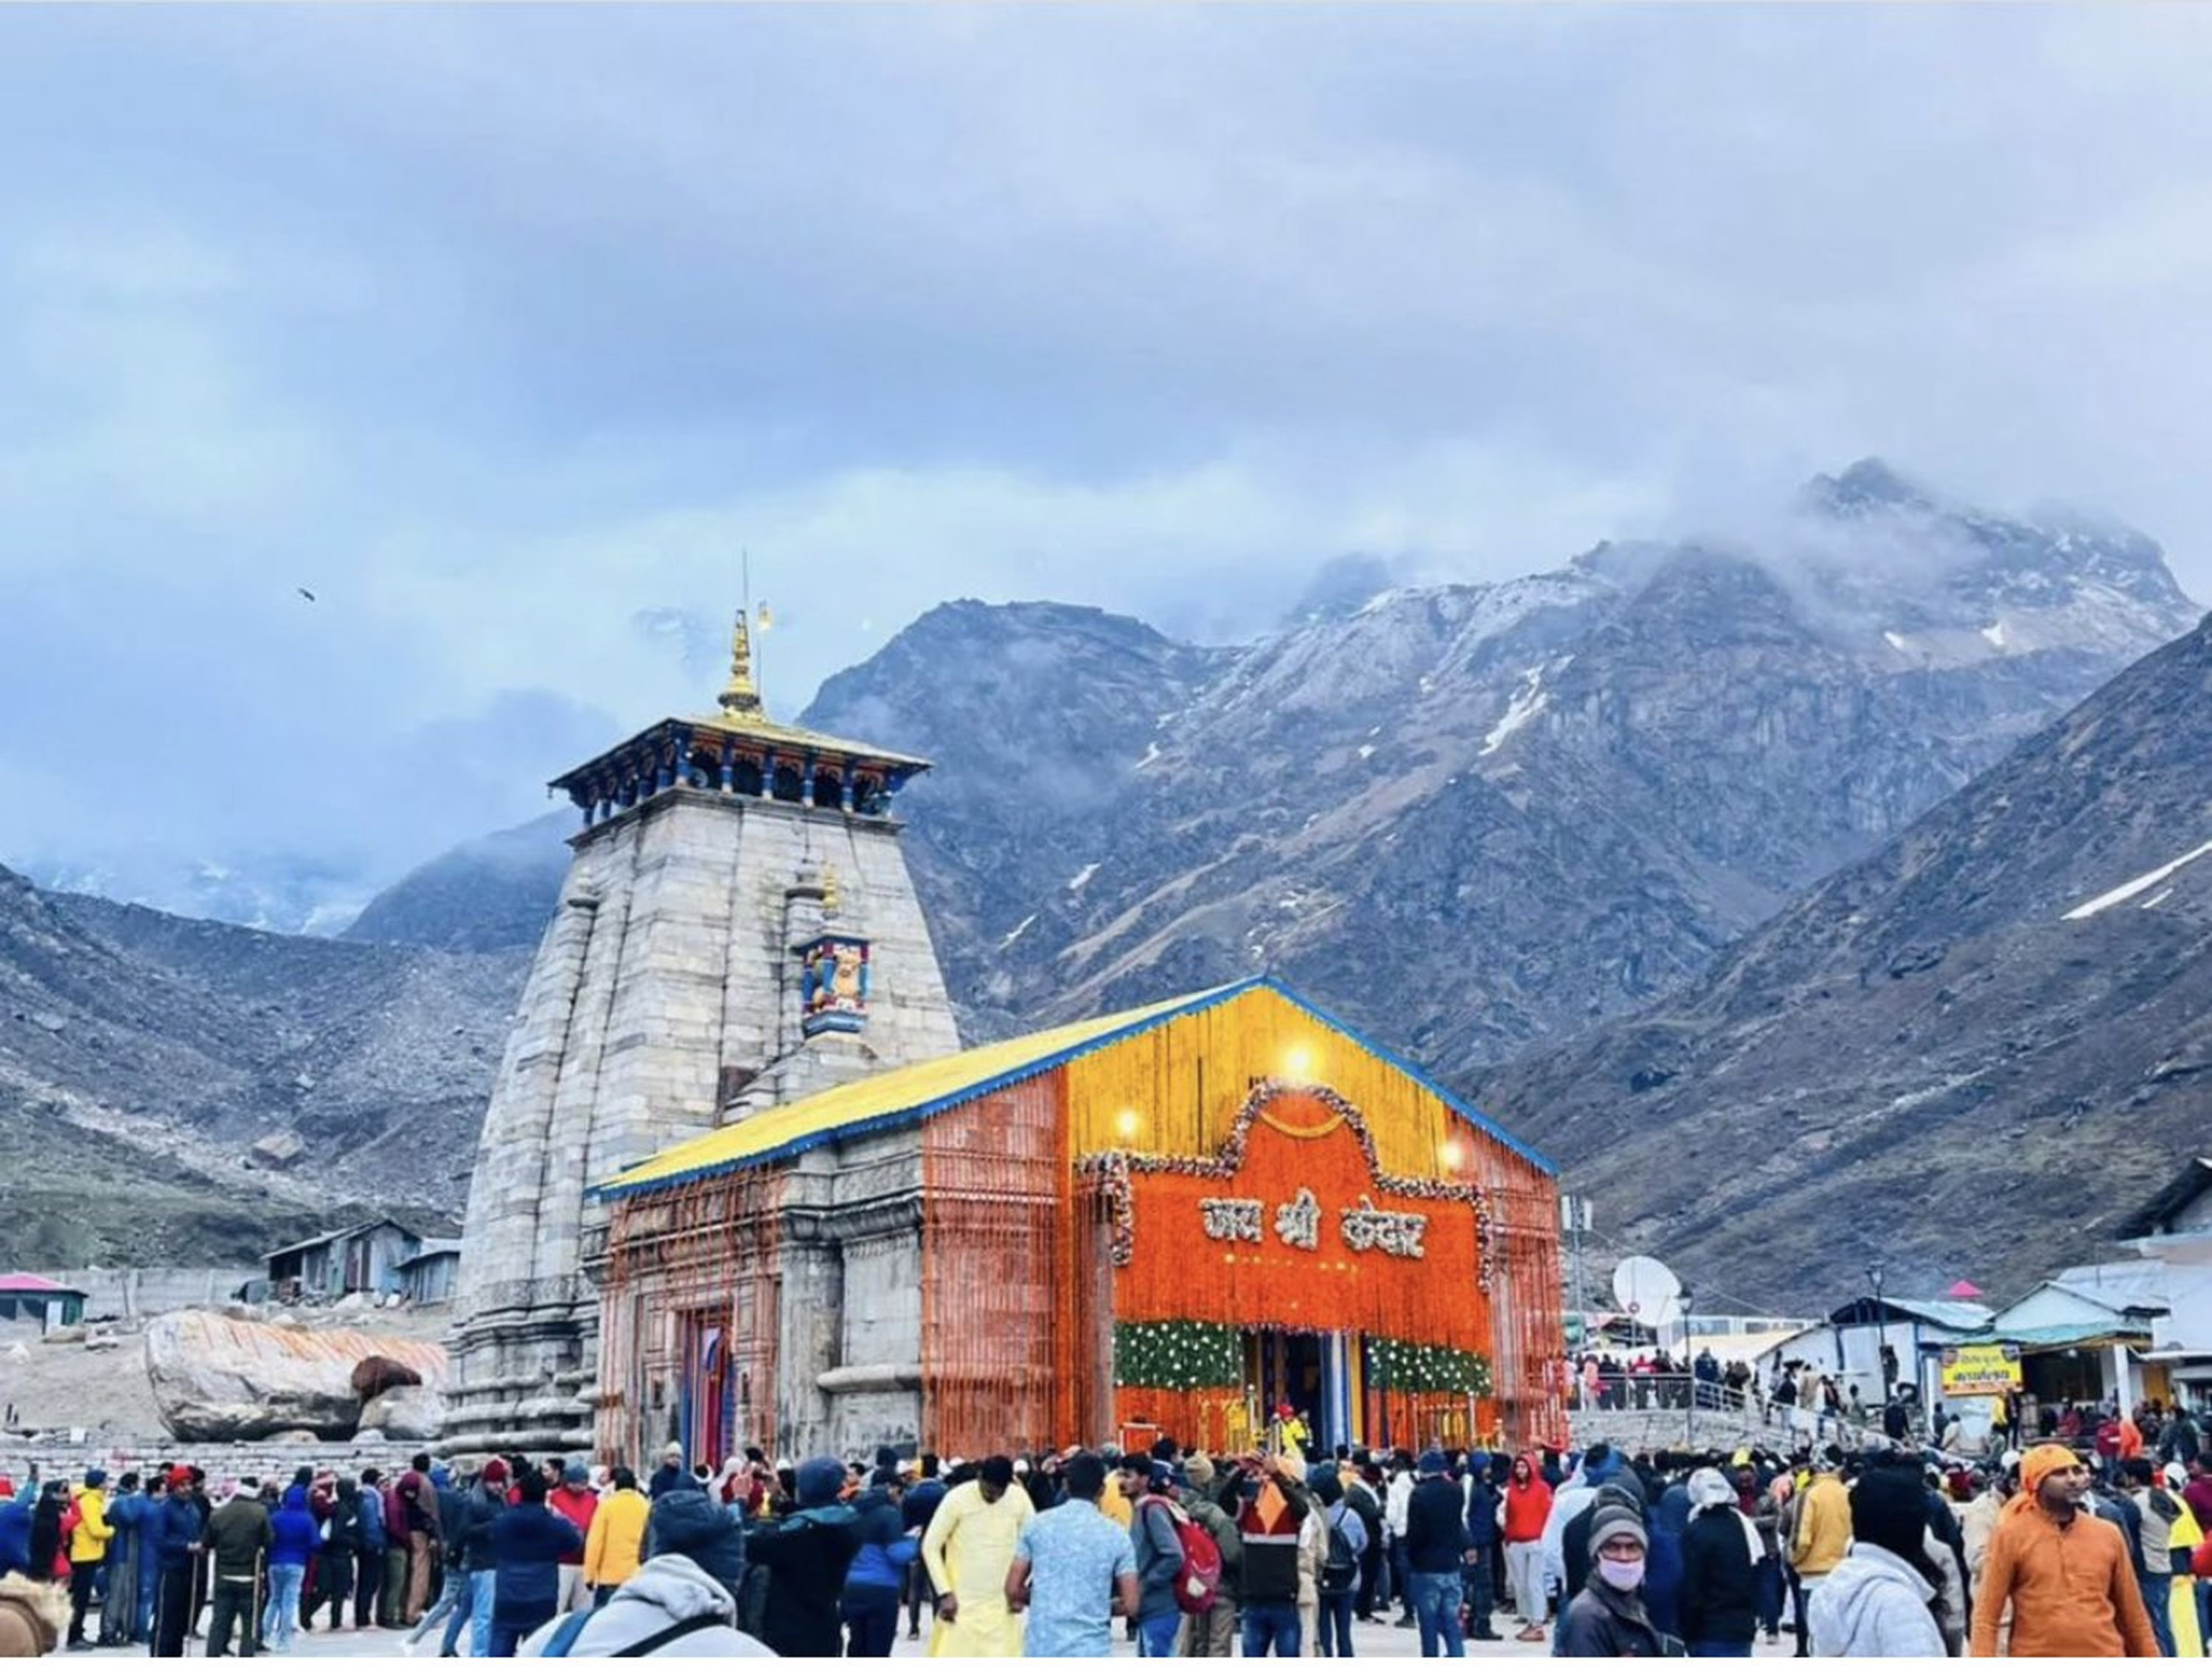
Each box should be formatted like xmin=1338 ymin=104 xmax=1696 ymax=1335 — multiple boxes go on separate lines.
xmin=354 ymin=460 xmax=2197 ymax=1069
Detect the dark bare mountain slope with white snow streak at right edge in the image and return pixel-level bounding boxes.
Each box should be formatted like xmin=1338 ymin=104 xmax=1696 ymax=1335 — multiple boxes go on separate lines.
xmin=1480 ymin=617 xmax=2212 ymax=1312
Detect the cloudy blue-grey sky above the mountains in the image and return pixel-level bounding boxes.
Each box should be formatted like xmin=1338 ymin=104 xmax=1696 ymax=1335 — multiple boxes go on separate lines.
xmin=0 ymin=7 xmax=2212 ymax=902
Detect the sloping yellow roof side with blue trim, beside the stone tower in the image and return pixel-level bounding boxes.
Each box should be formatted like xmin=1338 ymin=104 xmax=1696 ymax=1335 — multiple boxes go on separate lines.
xmin=599 ymin=980 xmax=1261 ymax=1197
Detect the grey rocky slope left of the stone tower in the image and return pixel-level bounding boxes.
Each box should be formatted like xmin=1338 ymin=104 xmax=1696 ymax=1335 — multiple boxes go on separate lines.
xmin=0 ymin=870 xmax=526 ymax=1266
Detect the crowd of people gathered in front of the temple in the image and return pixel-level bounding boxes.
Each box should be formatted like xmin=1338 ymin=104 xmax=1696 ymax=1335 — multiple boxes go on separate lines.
xmin=0 ymin=1416 xmax=2212 ymax=1657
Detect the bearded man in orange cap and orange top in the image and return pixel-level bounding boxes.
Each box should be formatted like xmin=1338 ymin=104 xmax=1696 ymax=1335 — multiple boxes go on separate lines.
xmin=1973 ymin=1443 xmax=2159 ymax=1657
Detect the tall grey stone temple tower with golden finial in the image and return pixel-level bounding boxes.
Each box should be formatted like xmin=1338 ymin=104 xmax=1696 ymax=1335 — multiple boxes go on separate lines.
xmin=445 ymin=615 xmax=960 ymax=1451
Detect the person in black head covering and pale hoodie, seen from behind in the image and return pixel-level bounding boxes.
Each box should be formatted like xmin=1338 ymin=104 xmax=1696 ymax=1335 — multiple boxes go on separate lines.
xmin=1807 ymin=1465 xmax=1944 ymax=1659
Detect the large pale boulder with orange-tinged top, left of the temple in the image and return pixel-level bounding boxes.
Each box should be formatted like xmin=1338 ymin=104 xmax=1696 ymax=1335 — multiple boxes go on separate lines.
xmin=146 ymin=1308 xmax=447 ymax=1440
